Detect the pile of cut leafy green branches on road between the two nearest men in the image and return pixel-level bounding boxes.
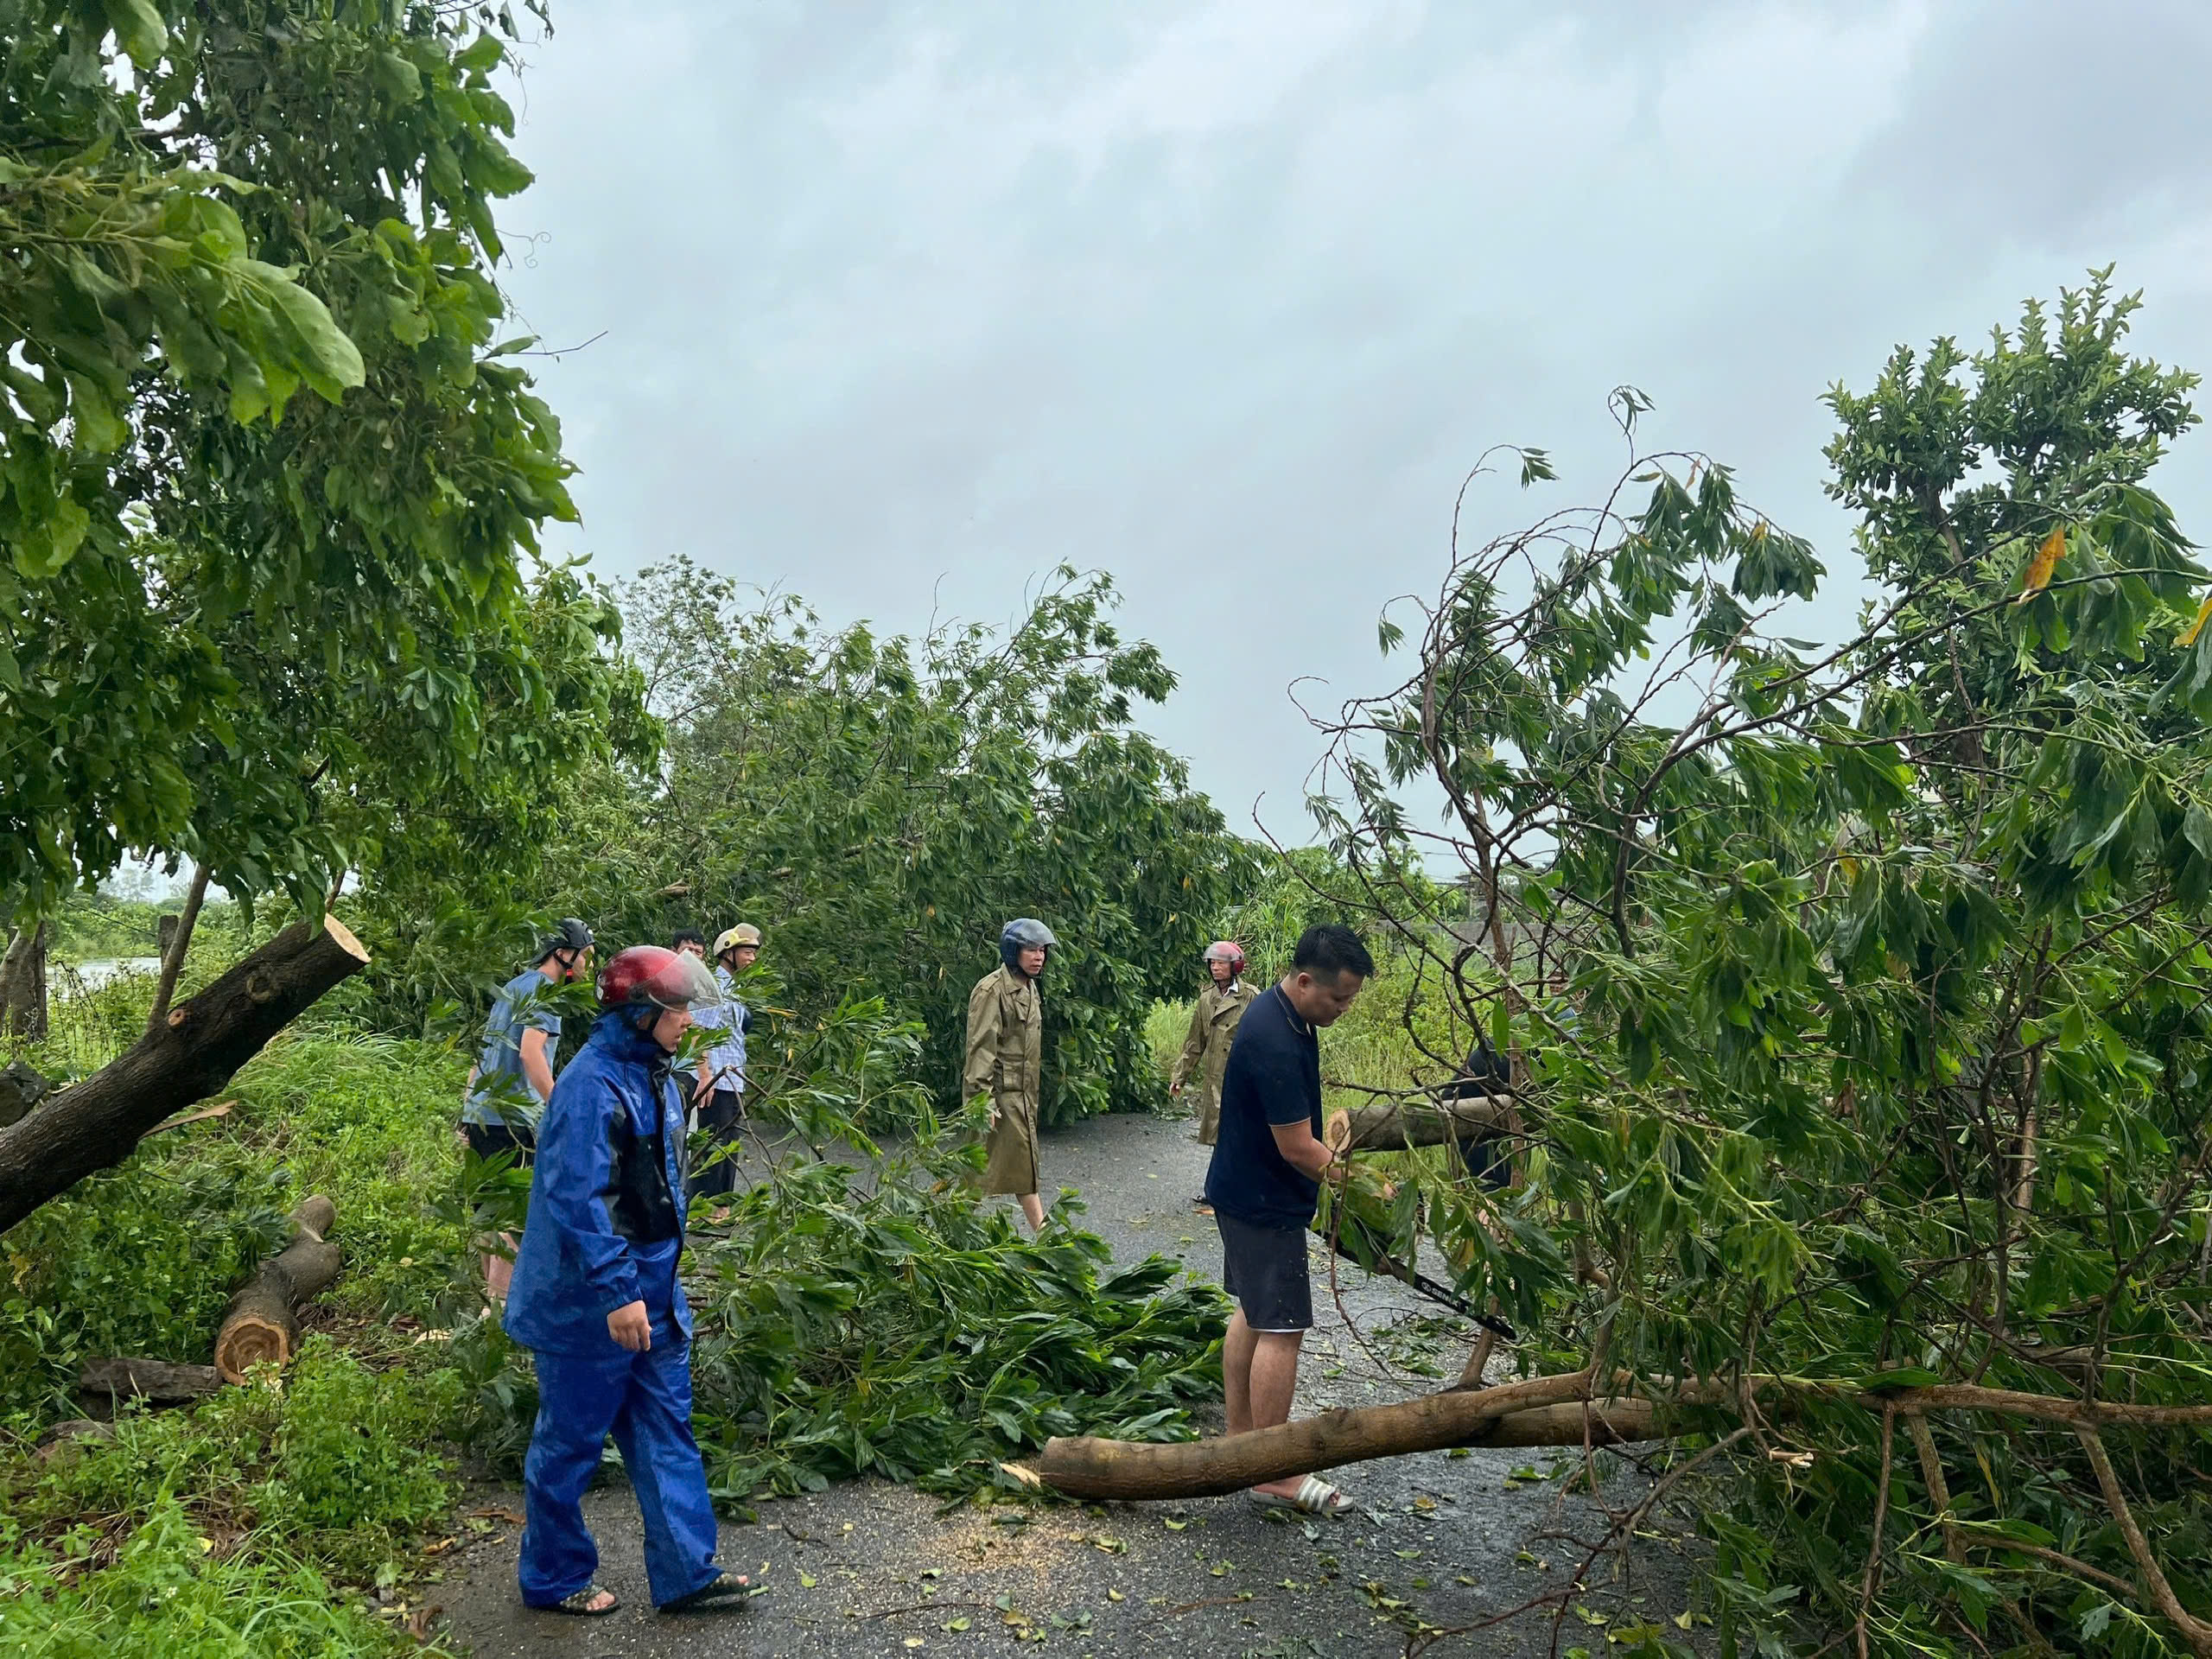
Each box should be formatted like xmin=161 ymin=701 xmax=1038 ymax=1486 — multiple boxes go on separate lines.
xmin=695 ymin=1164 xmax=1228 ymax=1497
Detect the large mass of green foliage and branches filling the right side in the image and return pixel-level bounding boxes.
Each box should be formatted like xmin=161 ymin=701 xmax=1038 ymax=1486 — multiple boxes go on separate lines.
xmin=1323 ymin=274 xmax=2212 ymax=1656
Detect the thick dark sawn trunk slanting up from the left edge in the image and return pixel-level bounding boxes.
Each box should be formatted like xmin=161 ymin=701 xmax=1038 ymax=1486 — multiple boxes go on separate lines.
xmin=0 ymin=916 xmax=370 ymax=1232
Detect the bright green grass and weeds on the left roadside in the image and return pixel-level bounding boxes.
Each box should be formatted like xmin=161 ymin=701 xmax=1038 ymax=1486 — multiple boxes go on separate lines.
xmin=0 ymin=969 xmax=474 ymax=1659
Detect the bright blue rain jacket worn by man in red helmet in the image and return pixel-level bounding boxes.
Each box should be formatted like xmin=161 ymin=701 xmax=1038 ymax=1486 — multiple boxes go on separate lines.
xmin=506 ymin=1013 xmax=692 ymax=1358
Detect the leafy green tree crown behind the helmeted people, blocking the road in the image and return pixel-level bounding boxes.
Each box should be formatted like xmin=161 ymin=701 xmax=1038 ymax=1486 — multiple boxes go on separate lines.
xmin=416 ymin=560 xmax=1256 ymax=1122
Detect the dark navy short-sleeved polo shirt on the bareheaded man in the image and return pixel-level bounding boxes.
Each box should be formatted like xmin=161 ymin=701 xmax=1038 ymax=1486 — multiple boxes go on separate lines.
xmin=1205 ymin=984 xmax=1320 ymax=1228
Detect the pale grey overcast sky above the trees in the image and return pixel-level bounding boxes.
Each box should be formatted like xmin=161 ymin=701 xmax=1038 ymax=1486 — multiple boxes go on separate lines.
xmin=502 ymin=0 xmax=2212 ymax=838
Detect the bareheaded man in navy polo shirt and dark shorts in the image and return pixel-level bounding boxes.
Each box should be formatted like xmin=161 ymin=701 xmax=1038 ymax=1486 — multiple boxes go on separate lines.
xmin=1205 ymin=925 xmax=1376 ymax=1516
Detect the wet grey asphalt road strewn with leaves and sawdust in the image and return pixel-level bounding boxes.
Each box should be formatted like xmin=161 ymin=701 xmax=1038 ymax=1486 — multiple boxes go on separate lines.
xmin=435 ymin=1117 xmax=1703 ymax=1659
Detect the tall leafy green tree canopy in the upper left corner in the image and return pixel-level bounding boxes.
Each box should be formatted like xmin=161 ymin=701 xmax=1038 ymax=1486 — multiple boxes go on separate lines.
xmin=0 ymin=0 xmax=635 ymax=913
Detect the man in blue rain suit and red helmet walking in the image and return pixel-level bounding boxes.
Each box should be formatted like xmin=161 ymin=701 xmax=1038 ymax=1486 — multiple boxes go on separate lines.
xmin=506 ymin=944 xmax=752 ymax=1617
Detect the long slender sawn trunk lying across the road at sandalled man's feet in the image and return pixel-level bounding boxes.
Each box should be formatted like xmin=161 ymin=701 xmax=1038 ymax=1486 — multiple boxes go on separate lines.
xmin=1031 ymin=1371 xmax=2212 ymax=1497
